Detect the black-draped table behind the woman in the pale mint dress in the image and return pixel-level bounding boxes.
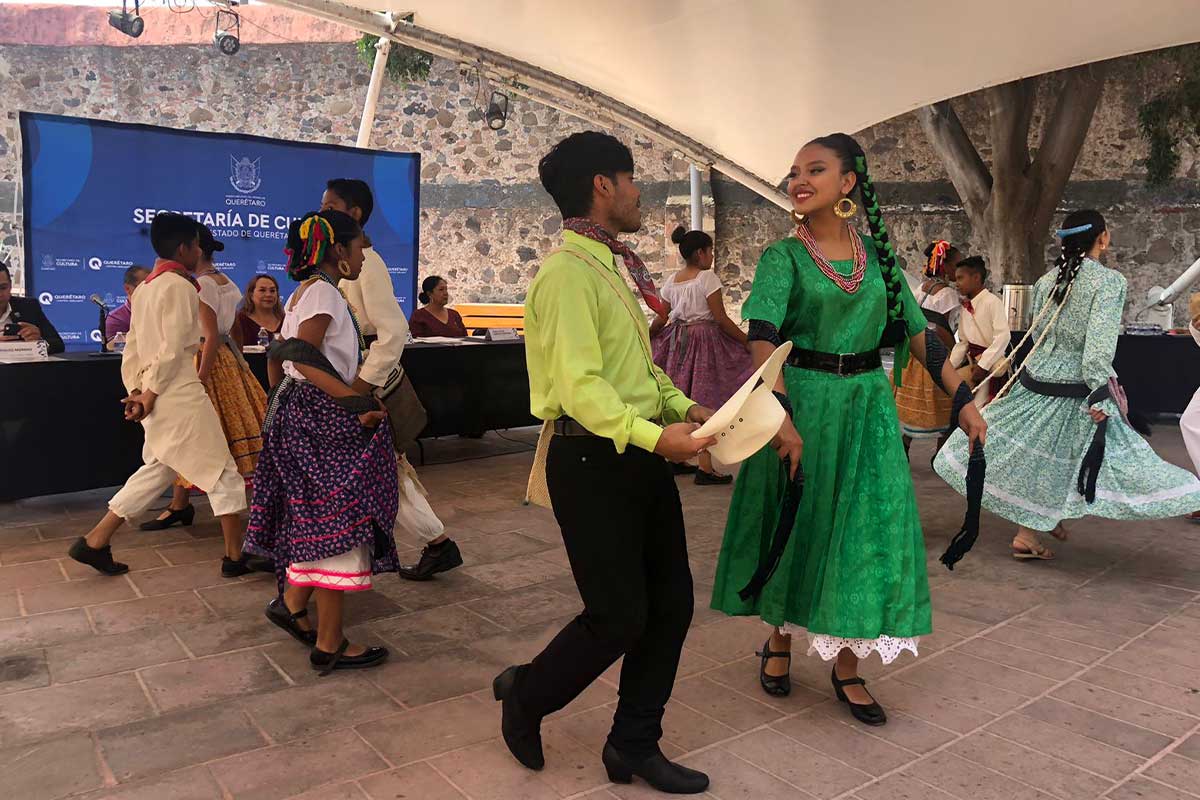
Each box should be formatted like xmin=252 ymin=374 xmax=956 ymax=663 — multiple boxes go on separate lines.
xmin=1013 ymin=332 xmax=1200 ymax=416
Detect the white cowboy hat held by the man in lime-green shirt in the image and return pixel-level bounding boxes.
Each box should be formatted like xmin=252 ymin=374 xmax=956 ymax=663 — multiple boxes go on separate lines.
xmin=691 ymin=342 xmax=792 ymax=464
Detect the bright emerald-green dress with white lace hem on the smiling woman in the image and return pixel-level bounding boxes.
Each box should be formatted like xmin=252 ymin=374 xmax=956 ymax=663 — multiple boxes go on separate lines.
xmin=712 ymin=237 xmax=931 ymax=663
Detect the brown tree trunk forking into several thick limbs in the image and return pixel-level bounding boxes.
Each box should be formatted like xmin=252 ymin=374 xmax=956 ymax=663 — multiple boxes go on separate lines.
xmin=917 ymin=64 xmax=1106 ymax=287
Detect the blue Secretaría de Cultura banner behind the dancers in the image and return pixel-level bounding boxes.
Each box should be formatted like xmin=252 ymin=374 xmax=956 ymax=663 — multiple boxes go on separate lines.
xmin=20 ymin=112 xmax=421 ymax=350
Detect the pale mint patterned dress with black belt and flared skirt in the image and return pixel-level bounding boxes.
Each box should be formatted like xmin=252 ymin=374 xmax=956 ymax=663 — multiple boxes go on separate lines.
xmin=934 ymin=259 xmax=1200 ymax=530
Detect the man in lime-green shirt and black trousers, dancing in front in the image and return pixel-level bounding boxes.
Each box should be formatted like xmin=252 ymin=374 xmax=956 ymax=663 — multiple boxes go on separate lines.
xmin=493 ymin=132 xmax=713 ymax=794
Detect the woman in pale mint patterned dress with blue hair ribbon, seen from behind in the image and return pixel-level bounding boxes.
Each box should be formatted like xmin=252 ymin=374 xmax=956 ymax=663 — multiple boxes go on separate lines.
xmin=934 ymin=210 xmax=1200 ymax=560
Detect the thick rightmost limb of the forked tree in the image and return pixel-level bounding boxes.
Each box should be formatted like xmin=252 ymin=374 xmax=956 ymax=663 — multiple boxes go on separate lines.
xmin=1031 ymin=62 xmax=1109 ymax=231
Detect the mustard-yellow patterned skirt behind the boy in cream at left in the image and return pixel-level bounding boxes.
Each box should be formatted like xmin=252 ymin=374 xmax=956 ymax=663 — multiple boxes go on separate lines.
xmin=176 ymin=342 xmax=266 ymax=488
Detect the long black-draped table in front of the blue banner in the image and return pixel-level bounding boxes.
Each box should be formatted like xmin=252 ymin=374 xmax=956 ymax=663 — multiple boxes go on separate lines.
xmin=0 ymin=341 xmax=538 ymax=500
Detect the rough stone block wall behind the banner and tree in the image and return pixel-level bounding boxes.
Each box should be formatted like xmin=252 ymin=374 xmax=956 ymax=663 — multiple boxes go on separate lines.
xmin=0 ymin=35 xmax=1200 ymax=318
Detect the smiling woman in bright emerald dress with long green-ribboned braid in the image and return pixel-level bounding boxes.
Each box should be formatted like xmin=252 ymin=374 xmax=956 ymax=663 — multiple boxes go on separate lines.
xmin=713 ymin=133 xmax=985 ymax=724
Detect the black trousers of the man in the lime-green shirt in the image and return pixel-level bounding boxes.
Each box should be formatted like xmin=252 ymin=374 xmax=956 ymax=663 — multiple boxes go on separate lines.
xmin=517 ymin=437 xmax=692 ymax=757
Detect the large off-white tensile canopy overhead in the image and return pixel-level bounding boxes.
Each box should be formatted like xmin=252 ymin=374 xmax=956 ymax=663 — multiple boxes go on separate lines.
xmin=266 ymin=0 xmax=1200 ymax=205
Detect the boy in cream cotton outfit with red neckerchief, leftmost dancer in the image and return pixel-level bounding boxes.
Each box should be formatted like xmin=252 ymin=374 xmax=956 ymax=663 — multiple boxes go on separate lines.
xmin=67 ymin=212 xmax=246 ymax=577
